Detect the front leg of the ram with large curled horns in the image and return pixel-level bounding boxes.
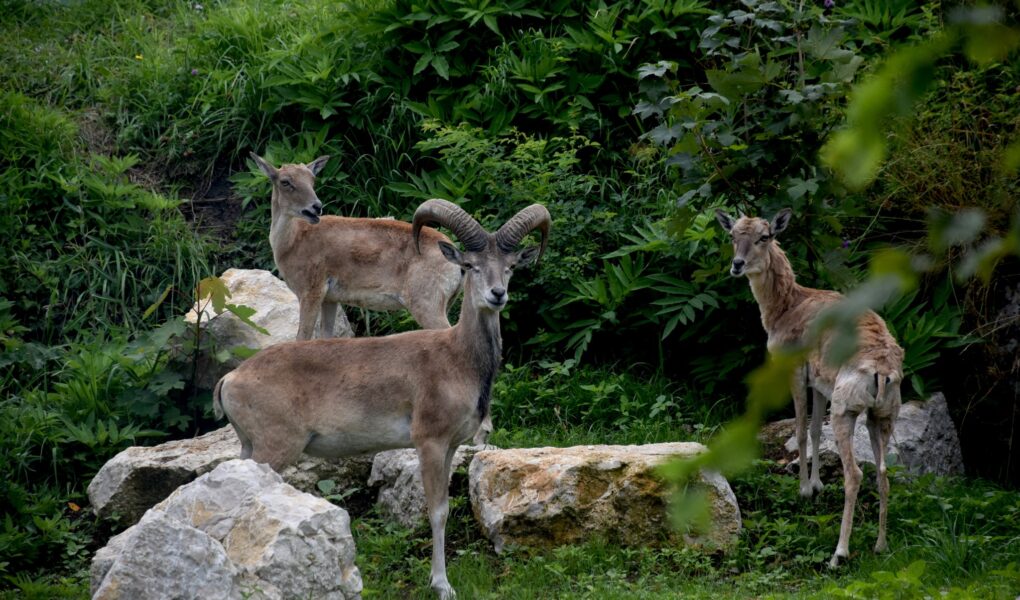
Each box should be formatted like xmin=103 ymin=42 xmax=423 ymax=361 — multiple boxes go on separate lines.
xmin=417 ymin=441 xmax=457 ymax=600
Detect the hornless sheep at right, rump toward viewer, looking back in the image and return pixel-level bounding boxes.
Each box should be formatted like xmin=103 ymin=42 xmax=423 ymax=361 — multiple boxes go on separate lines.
xmin=716 ymin=208 xmax=903 ymax=566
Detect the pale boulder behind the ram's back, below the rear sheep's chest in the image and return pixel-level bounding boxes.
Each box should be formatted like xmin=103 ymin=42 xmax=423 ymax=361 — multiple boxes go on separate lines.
xmin=185 ymin=268 xmax=354 ymax=390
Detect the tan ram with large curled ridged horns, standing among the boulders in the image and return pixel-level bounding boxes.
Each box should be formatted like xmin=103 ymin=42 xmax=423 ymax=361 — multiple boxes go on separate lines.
xmin=213 ymin=200 xmax=549 ymax=598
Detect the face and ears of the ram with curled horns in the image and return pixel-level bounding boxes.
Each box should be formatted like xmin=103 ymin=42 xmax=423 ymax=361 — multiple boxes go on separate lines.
xmin=440 ymin=242 xmax=539 ymax=312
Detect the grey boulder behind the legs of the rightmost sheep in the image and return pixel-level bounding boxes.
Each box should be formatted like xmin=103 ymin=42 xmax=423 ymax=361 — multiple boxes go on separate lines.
xmin=759 ymin=393 xmax=964 ymax=479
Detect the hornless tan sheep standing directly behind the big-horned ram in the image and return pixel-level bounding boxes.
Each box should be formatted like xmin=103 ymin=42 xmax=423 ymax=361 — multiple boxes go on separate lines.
xmin=252 ymin=154 xmax=461 ymax=340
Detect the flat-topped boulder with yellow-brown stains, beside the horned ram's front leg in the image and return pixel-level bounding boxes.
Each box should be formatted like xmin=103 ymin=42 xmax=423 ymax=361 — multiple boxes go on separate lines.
xmin=469 ymin=443 xmax=741 ymax=552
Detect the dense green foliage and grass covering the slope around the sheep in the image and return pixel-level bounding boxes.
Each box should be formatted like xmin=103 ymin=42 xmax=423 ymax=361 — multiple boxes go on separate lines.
xmin=0 ymin=0 xmax=1020 ymax=597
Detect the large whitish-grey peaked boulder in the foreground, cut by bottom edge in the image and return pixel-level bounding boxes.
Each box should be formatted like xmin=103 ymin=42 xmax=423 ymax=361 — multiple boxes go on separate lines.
xmin=90 ymin=459 xmax=361 ymax=600
